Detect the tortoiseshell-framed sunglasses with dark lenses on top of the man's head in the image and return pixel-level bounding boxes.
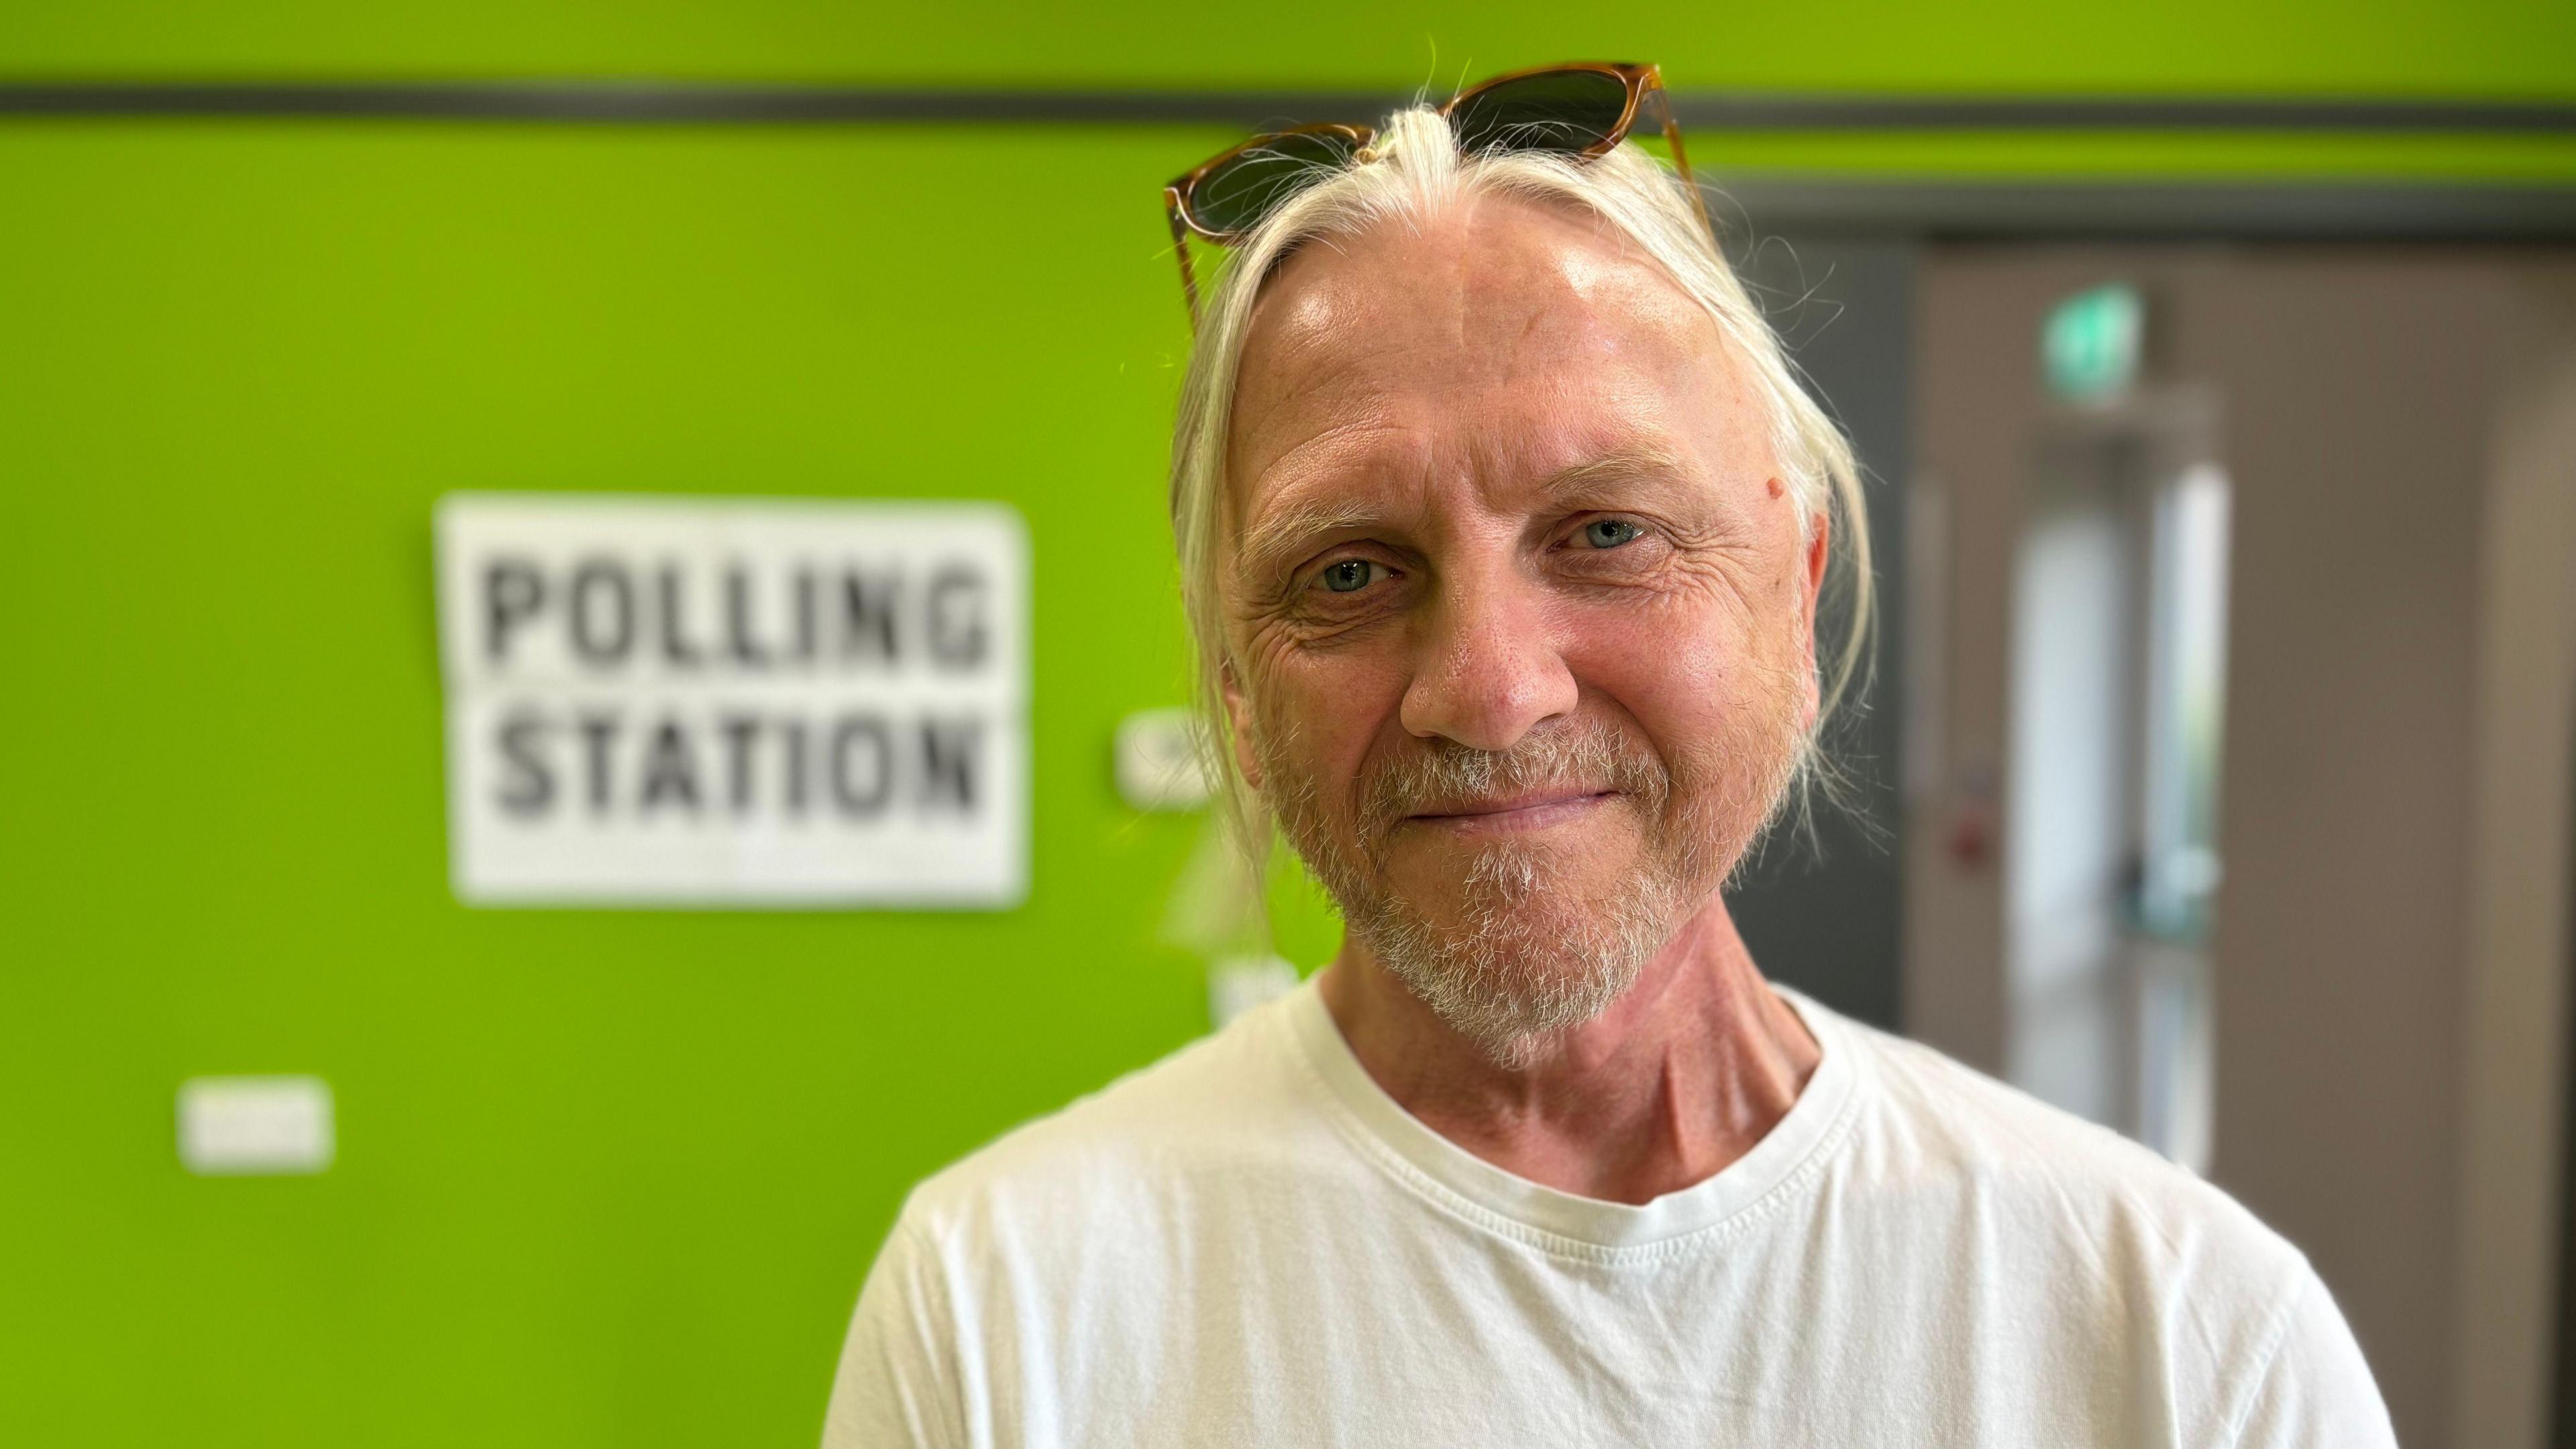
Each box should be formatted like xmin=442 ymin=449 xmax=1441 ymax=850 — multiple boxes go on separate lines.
xmin=1162 ymin=62 xmax=1690 ymax=325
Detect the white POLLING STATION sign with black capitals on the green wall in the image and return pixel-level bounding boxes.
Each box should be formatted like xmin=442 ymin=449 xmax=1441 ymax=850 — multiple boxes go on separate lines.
xmin=438 ymin=492 xmax=1028 ymax=908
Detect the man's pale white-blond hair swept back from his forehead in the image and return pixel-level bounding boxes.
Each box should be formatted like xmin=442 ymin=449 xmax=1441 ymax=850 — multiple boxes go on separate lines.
xmin=1172 ymin=106 xmax=1873 ymax=861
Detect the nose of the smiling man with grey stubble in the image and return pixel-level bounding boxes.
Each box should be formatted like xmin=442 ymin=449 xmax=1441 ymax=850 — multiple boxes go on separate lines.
xmin=1401 ymin=570 xmax=1579 ymax=750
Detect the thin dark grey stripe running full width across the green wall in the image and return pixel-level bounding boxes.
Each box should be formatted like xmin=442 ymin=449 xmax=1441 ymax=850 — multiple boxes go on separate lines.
xmin=0 ymin=80 xmax=2576 ymax=134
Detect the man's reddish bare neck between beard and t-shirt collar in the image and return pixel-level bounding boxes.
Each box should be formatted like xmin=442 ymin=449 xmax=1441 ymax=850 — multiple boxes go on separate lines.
xmin=1322 ymin=895 xmax=1821 ymax=1201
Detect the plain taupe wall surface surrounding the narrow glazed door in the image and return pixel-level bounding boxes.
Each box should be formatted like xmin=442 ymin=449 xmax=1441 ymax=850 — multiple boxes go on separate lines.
xmin=1907 ymin=248 xmax=2576 ymax=1449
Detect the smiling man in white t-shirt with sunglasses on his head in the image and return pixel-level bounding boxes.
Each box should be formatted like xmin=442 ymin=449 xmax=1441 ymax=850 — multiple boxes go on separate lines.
xmin=824 ymin=67 xmax=2391 ymax=1449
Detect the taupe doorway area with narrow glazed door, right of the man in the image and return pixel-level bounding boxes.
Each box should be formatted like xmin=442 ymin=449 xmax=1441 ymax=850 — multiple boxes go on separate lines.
xmin=1901 ymin=242 xmax=2576 ymax=1446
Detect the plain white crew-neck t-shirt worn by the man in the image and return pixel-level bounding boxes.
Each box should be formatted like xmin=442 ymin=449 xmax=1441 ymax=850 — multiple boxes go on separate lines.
xmin=824 ymin=982 xmax=2393 ymax=1449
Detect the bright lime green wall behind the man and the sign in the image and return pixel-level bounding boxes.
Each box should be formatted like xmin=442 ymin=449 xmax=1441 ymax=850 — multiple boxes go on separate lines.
xmin=0 ymin=0 xmax=2576 ymax=1446
